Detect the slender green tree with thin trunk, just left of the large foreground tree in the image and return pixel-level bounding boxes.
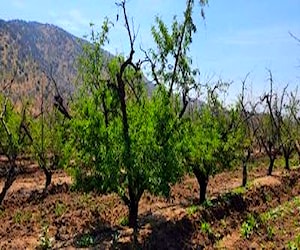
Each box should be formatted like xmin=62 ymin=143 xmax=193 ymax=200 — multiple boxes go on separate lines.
xmin=28 ymin=79 xmax=70 ymax=190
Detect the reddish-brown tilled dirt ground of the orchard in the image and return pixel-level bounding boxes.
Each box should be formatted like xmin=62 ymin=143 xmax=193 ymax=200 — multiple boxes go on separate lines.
xmin=0 ymin=157 xmax=300 ymax=249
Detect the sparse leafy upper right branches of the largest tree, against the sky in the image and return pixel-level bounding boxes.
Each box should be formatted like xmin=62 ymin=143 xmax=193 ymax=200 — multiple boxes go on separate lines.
xmin=148 ymin=0 xmax=199 ymax=99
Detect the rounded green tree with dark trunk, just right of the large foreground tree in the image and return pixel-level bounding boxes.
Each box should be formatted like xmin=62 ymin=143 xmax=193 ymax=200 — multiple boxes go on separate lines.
xmin=186 ymin=88 xmax=243 ymax=203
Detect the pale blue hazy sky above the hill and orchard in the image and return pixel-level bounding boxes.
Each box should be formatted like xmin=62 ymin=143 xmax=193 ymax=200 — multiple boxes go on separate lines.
xmin=0 ymin=0 xmax=300 ymax=100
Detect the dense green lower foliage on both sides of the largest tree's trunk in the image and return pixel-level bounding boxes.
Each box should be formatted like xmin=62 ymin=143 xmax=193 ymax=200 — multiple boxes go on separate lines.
xmin=70 ymin=84 xmax=181 ymax=195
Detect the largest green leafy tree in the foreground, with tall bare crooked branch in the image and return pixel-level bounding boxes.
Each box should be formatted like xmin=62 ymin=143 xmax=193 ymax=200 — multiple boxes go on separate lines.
xmin=66 ymin=1 xmax=204 ymax=229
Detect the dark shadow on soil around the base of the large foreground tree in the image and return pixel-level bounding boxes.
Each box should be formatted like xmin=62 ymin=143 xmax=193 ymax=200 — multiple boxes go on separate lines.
xmin=72 ymin=214 xmax=193 ymax=249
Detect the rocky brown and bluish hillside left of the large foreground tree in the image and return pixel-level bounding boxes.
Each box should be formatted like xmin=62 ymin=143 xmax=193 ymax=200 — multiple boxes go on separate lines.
xmin=0 ymin=20 xmax=85 ymax=105
